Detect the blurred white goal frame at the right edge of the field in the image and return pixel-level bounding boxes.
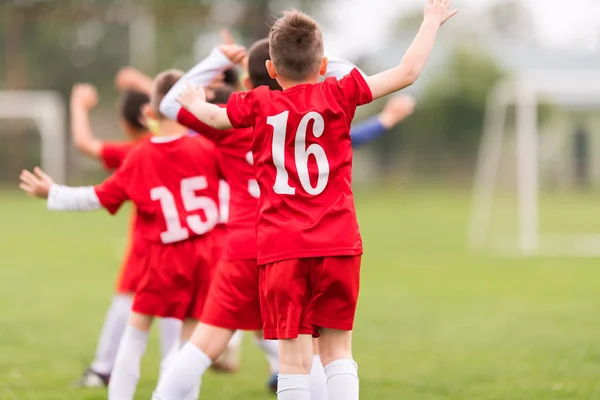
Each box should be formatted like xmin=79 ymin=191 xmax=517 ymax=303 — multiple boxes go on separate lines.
xmin=468 ymin=70 xmax=600 ymax=256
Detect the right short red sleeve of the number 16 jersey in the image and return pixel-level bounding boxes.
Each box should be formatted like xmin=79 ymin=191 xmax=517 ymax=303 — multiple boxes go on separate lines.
xmin=325 ymin=68 xmax=373 ymax=119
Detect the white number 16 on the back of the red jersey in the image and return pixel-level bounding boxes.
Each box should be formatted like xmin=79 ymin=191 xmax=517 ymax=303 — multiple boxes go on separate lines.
xmin=267 ymin=111 xmax=329 ymax=196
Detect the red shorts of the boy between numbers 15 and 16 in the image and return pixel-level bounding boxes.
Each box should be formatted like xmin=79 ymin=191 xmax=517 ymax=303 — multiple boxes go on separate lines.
xmin=201 ymin=259 xmax=263 ymax=331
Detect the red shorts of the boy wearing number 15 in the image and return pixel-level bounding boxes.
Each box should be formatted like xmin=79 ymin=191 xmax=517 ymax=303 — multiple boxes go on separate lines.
xmin=132 ymin=233 xmax=216 ymax=320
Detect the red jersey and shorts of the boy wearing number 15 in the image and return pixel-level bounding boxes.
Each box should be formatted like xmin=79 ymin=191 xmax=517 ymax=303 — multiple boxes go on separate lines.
xmin=95 ymin=137 xmax=221 ymax=319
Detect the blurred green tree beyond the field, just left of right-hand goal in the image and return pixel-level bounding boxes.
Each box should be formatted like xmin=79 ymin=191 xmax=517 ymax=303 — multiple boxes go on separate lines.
xmin=404 ymin=45 xmax=504 ymax=176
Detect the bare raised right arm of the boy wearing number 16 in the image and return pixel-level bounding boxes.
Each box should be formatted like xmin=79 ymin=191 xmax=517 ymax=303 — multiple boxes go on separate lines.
xmin=366 ymin=0 xmax=457 ymax=99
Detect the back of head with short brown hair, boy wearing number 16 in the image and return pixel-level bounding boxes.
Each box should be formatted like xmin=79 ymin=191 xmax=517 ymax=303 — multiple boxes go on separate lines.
xmin=269 ymin=11 xmax=324 ymax=82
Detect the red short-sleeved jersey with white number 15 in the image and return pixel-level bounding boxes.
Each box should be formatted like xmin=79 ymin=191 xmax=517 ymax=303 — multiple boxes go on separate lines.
xmin=96 ymin=137 xmax=221 ymax=244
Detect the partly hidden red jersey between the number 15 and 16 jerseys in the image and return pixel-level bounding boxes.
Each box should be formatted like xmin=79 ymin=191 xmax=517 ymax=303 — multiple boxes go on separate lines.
xmin=177 ymin=108 xmax=259 ymax=260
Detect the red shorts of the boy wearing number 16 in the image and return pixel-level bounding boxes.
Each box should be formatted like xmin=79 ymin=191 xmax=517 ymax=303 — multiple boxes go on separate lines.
xmin=259 ymin=256 xmax=361 ymax=340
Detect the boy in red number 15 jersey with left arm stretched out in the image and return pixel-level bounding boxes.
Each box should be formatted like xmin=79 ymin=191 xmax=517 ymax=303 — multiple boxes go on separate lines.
xmin=20 ymin=71 xmax=221 ymax=400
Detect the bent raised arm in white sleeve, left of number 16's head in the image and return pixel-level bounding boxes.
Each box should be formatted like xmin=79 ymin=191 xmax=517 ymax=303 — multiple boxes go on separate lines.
xmin=160 ymin=44 xmax=246 ymax=120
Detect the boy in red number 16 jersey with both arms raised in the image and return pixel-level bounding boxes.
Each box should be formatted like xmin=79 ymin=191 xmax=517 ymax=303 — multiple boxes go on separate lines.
xmin=169 ymin=0 xmax=456 ymax=400
